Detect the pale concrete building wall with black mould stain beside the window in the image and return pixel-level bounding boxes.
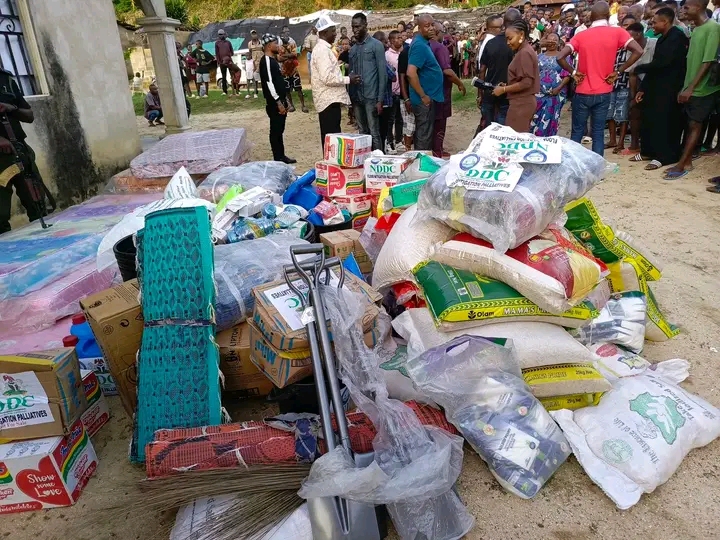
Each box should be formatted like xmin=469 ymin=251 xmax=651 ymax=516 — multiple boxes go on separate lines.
xmin=16 ymin=0 xmax=140 ymax=217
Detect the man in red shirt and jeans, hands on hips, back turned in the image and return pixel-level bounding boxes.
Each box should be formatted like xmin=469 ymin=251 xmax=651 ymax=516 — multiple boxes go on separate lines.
xmin=557 ymin=1 xmax=643 ymax=156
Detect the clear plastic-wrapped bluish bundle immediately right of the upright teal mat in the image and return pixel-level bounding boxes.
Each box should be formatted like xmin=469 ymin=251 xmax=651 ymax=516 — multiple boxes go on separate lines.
xmin=215 ymin=235 xmax=307 ymax=330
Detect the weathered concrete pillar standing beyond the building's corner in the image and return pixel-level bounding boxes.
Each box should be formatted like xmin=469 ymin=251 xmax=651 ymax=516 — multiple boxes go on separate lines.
xmin=138 ymin=17 xmax=190 ymax=134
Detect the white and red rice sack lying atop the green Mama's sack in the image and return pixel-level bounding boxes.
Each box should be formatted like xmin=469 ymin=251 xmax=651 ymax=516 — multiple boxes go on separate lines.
xmin=430 ymin=226 xmax=608 ymax=314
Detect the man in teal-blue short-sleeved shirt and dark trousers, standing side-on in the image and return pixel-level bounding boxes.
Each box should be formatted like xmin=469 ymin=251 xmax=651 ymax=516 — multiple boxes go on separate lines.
xmin=407 ymin=14 xmax=445 ymax=150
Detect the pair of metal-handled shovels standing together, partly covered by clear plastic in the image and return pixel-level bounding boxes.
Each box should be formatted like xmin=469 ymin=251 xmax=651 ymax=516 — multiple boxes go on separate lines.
xmin=283 ymin=244 xmax=385 ymax=540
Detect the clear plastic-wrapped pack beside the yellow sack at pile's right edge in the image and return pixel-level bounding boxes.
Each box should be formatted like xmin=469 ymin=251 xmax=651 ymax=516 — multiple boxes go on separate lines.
xmin=570 ymin=291 xmax=647 ymax=353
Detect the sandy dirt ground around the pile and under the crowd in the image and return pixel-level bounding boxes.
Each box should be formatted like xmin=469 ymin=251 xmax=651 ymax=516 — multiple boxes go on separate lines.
xmin=7 ymin=106 xmax=720 ymax=540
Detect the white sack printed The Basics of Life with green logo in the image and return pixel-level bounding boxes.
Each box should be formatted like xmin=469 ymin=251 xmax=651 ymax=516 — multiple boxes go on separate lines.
xmin=551 ymin=371 xmax=720 ymax=510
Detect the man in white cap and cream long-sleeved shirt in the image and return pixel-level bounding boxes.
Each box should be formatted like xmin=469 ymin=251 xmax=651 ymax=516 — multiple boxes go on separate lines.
xmin=310 ymin=15 xmax=360 ymax=150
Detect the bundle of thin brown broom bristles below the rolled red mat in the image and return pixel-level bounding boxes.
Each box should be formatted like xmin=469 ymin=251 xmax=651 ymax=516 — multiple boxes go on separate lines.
xmin=97 ymin=463 xmax=310 ymax=540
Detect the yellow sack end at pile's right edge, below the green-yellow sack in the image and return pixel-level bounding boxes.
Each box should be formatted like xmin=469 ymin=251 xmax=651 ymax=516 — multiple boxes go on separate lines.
xmin=607 ymin=258 xmax=680 ymax=341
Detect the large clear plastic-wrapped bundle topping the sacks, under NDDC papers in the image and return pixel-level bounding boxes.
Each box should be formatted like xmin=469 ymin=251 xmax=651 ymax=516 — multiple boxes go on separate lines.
xmin=416 ymin=126 xmax=616 ymax=253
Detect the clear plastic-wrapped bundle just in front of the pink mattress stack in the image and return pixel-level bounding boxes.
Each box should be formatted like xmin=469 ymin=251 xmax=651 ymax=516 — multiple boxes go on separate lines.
xmin=198 ymin=161 xmax=295 ymax=203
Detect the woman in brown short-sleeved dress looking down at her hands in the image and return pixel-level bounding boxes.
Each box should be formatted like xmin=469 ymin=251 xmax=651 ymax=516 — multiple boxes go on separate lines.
xmin=493 ymin=19 xmax=540 ymax=133
